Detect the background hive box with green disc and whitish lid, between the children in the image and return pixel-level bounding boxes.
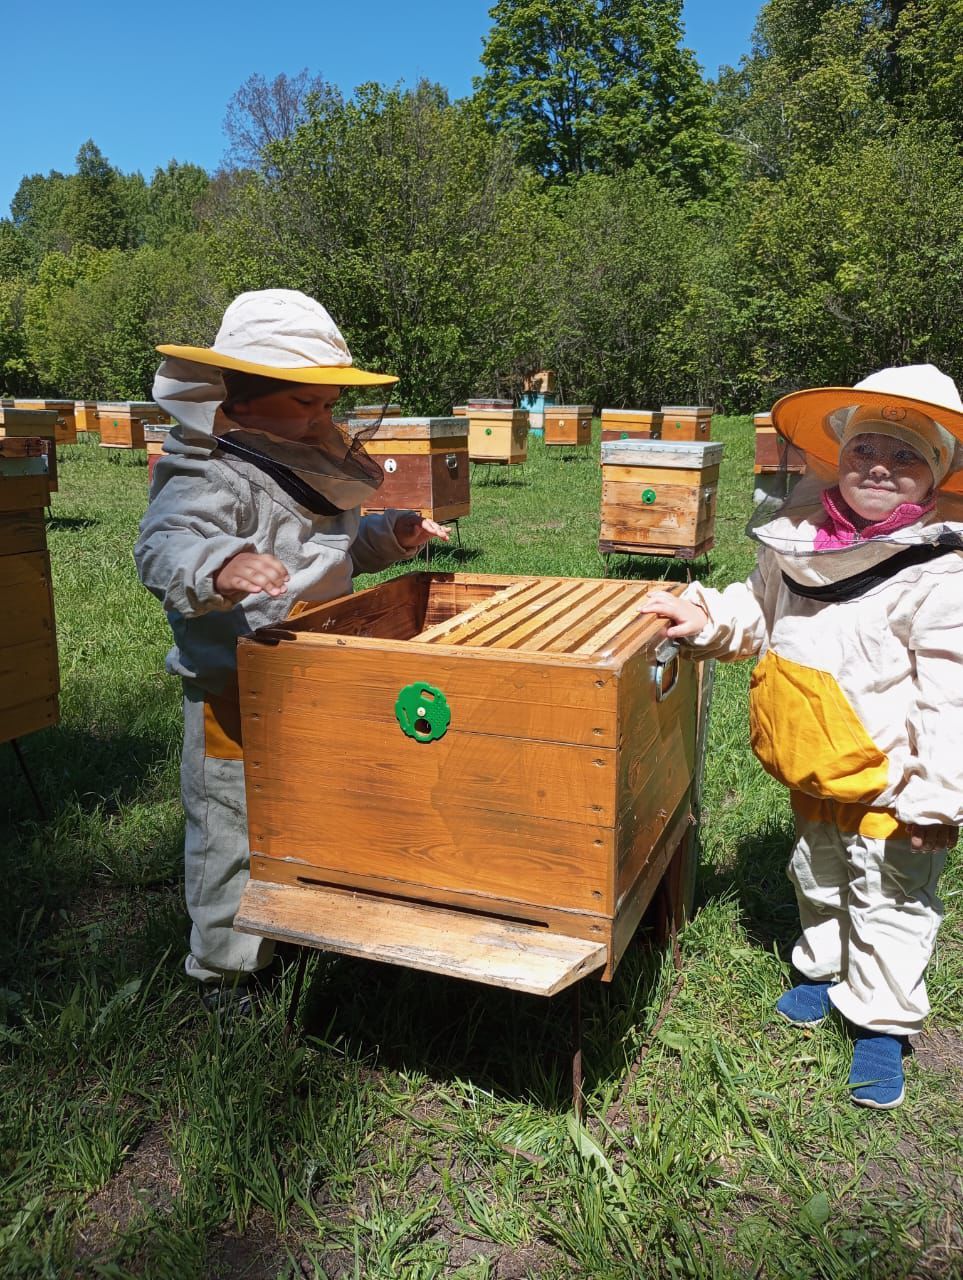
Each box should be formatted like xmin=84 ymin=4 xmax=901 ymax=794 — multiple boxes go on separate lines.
xmin=598 ymin=439 xmax=722 ymax=559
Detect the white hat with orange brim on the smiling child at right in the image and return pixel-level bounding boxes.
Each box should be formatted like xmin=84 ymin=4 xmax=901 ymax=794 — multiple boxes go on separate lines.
xmin=772 ymin=365 xmax=963 ymax=494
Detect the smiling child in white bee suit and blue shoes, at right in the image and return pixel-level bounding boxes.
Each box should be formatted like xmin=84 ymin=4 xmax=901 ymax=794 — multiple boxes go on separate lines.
xmin=644 ymin=365 xmax=963 ymax=1108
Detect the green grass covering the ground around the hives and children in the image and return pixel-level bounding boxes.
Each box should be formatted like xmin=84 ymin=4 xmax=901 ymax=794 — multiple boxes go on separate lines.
xmin=0 ymin=430 xmax=963 ymax=1280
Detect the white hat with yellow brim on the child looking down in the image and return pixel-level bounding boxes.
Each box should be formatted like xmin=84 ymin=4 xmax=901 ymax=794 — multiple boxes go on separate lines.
xmin=158 ymin=289 xmax=398 ymax=387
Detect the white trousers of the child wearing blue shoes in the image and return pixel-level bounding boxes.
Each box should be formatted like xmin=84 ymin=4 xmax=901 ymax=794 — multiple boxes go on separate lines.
xmin=789 ymin=815 xmax=946 ymax=1036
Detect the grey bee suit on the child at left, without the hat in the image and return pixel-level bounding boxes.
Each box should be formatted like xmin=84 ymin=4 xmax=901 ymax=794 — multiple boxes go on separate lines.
xmin=134 ymin=358 xmax=414 ymax=982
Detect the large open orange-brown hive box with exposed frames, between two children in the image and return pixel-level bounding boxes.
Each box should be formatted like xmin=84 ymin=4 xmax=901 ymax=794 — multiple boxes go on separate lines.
xmin=234 ymin=573 xmax=697 ymax=995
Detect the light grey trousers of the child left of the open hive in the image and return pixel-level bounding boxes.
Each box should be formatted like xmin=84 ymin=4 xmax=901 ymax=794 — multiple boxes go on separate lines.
xmin=181 ymin=681 xmax=274 ymax=982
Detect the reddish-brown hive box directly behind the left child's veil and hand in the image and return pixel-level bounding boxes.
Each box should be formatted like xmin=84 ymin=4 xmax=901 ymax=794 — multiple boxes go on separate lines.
xmin=362 ymin=417 xmax=471 ymax=521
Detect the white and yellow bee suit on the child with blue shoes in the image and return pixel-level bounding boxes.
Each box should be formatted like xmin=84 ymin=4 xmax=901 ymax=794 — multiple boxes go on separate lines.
xmin=685 ymin=480 xmax=963 ymax=1034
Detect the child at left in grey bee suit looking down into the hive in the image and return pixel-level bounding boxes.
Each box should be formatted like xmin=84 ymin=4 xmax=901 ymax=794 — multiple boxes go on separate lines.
xmin=134 ymin=289 xmax=448 ymax=1010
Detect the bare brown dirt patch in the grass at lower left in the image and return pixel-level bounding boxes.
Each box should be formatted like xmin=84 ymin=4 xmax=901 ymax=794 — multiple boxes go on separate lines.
xmin=74 ymin=1126 xmax=181 ymax=1262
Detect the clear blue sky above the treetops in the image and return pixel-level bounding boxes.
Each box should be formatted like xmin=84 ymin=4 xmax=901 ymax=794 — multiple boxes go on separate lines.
xmin=0 ymin=0 xmax=762 ymax=215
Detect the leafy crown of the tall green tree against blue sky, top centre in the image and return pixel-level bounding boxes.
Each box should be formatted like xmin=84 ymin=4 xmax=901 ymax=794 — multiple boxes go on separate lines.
xmin=476 ymin=0 xmax=727 ymax=195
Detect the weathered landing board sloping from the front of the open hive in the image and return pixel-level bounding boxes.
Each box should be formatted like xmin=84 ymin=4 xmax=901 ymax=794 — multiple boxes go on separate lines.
xmin=234 ymin=881 xmax=607 ymax=996
